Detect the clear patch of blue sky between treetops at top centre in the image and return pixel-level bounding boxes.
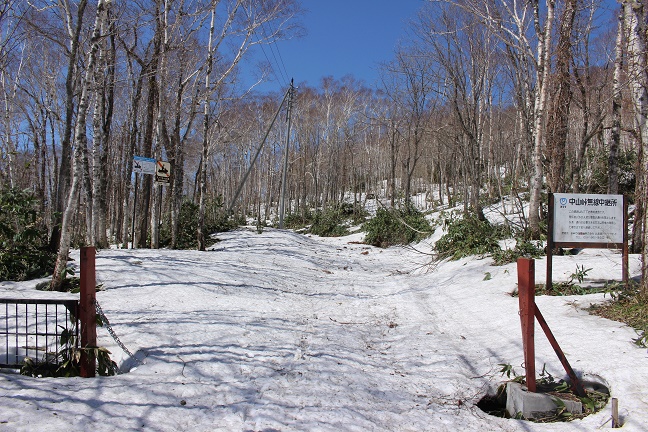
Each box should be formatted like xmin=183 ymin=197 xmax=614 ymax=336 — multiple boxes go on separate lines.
xmin=249 ymin=0 xmax=425 ymax=91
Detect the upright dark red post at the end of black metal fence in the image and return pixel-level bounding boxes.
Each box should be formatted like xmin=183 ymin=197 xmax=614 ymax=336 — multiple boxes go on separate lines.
xmin=79 ymin=247 xmax=97 ymax=378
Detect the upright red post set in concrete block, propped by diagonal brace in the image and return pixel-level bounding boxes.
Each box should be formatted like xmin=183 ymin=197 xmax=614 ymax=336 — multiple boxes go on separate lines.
xmin=517 ymin=258 xmax=536 ymax=393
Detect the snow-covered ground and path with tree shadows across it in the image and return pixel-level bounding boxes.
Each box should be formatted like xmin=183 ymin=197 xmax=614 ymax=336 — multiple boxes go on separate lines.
xmin=0 ymin=229 xmax=648 ymax=432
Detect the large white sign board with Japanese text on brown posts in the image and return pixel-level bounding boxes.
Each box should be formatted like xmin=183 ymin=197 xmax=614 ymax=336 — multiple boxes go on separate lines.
xmin=553 ymin=193 xmax=625 ymax=243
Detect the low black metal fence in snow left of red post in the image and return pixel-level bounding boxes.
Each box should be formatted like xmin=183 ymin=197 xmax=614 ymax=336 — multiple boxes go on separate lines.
xmin=0 ymin=299 xmax=79 ymax=368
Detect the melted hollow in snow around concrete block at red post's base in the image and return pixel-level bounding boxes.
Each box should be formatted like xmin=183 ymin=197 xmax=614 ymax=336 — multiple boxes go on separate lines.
xmin=477 ymin=376 xmax=610 ymax=423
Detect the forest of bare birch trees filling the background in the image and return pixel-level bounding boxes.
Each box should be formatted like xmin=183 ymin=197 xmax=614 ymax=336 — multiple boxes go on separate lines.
xmin=0 ymin=0 xmax=648 ymax=294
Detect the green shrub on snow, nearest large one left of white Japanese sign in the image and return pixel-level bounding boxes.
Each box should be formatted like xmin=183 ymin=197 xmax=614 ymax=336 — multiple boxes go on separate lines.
xmin=434 ymin=215 xmax=503 ymax=260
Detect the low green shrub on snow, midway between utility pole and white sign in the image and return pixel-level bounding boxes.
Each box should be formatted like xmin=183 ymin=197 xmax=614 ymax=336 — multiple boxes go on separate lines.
xmin=363 ymin=206 xmax=432 ymax=247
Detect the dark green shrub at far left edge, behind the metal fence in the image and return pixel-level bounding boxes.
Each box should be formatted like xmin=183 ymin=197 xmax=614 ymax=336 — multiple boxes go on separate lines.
xmin=0 ymin=188 xmax=56 ymax=281
